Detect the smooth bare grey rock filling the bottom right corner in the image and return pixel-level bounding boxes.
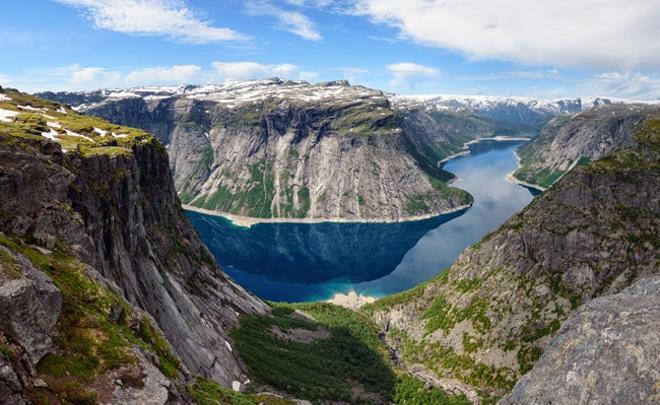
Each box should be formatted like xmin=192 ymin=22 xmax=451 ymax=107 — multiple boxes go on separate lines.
xmin=501 ymin=276 xmax=660 ymax=405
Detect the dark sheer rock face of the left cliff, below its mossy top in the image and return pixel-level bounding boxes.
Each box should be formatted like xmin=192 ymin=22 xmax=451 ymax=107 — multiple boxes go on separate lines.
xmin=0 ymin=133 xmax=267 ymax=385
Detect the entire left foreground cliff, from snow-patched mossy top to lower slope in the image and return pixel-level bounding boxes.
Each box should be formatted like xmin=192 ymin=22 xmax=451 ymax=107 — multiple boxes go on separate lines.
xmin=0 ymin=89 xmax=268 ymax=403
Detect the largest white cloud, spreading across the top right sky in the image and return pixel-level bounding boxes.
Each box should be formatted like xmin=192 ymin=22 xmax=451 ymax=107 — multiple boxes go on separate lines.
xmin=352 ymin=0 xmax=660 ymax=70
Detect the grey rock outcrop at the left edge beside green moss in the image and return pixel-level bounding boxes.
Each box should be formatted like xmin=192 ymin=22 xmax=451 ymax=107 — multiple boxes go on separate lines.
xmin=0 ymin=247 xmax=62 ymax=367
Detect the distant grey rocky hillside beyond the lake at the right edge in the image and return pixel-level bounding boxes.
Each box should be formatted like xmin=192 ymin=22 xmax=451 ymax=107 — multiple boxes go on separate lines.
xmin=514 ymin=104 xmax=660 ymax=188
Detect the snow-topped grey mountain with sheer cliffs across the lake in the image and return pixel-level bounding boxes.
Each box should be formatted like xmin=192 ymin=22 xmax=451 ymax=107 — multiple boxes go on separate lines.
xmin=41 ymin=79 xmax=548 ymax=221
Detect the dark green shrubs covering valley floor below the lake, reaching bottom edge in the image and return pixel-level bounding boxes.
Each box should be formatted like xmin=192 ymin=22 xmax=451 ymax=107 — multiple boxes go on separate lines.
xmin=232 ymin=302 xmax=468 ymax=404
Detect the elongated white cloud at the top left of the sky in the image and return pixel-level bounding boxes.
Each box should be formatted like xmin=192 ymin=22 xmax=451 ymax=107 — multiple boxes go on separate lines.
xmin=55 ymin=0 xmax=246 ymax=44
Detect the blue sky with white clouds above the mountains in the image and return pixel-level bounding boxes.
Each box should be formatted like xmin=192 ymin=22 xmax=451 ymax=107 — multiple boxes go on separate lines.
xmin=0 ymin=0 xmax=660 ymax=99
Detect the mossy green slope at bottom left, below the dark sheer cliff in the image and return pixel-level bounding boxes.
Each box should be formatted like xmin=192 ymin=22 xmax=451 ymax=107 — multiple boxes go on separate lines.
xmin=0 ymin=234 xmax=179 ymax=403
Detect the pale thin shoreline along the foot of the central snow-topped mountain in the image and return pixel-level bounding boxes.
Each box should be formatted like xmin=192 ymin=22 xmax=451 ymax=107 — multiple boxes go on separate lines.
xmin=181 ymin=204 xmax=472 ymax=228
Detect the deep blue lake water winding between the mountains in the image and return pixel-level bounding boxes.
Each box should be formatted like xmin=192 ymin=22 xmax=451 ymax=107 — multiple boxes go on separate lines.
xmin=188 ymin=142 xmax=533 ymax=302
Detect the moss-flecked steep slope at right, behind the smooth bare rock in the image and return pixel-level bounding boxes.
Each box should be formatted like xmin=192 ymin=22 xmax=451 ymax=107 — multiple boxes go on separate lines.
xmin=362 ymin=113 xmax=660 ymax=403
